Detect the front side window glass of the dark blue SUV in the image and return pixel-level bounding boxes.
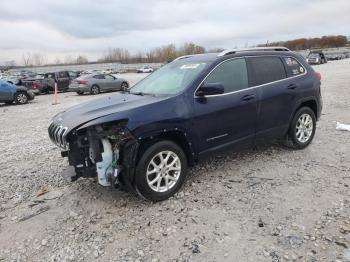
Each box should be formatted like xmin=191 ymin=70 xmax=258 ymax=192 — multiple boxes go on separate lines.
xmin=204 ymin=58 xmax=248 ymax=93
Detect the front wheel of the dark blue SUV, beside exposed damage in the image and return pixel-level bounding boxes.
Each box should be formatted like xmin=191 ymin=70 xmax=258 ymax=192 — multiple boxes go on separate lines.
xmin=135 ymin=140 xmax=187 ymax=201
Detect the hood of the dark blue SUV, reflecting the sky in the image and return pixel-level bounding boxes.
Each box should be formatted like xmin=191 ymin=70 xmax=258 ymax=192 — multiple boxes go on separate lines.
xmin=52 ymin=93 xmax=166 ymax=132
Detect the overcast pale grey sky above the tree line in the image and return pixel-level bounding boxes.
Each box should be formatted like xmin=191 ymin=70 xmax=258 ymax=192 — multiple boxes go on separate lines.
xmin=0 ymin=0 xmax=350 ymax=64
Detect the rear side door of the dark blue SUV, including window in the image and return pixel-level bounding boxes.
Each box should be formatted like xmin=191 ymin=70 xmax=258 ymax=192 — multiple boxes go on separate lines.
xmin=247 ymin=56 xmax=298 ymax=140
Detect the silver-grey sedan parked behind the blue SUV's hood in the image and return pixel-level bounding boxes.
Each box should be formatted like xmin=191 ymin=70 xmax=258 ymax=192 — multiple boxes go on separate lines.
xmin=69 ymin=74 xmax=129 ymax=95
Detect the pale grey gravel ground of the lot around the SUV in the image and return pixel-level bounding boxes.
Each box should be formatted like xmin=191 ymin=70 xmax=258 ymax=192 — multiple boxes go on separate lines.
xmin=0 ymin=62 xmax=350 ymax=262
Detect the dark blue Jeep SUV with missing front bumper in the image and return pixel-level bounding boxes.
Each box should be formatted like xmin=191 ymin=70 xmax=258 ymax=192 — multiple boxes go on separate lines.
xmin=49 ymin=47 xmax=322 ymax=201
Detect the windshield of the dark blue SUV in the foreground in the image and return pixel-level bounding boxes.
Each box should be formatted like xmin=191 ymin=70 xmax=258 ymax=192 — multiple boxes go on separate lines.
xmin=130 ymin=61 xmax=207 ymax=95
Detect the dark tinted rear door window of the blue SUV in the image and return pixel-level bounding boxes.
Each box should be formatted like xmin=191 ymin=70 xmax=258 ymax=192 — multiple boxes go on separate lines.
xmin=248 ymin=56 xmax=287 ymax=86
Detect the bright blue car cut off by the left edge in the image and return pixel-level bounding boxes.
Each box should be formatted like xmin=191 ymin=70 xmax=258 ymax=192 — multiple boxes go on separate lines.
xmin=0 ymin=80 xmax=35 ymax=104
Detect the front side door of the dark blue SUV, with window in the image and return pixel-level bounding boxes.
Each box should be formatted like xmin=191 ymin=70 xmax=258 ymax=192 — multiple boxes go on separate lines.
xmin=193 ymin=58 xmax=257 ymax=153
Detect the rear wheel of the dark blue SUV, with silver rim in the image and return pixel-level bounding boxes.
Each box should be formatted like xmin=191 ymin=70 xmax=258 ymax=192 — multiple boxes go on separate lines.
xmin=285 ymin=107 xmax=316 ymax=149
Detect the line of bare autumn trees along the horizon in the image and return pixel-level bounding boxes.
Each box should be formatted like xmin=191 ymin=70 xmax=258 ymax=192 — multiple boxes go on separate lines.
xmin=16 ymin=35 xmax=349 ymax=66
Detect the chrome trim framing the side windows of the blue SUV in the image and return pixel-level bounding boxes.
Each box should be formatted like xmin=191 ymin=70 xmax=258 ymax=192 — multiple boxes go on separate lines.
xmin=193 ymin=55 xmax=308 ymax=98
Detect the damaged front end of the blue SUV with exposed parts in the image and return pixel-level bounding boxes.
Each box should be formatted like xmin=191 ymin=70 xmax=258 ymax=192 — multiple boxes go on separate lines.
xmin=49 ymin=121 xmax=139 ymax=190
